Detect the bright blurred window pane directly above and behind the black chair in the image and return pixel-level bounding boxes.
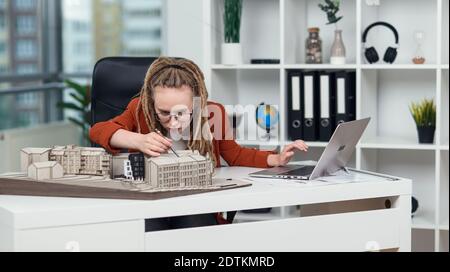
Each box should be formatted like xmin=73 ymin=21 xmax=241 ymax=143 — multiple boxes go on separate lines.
xmin=62 ymin=0 xmax=163 ymax=73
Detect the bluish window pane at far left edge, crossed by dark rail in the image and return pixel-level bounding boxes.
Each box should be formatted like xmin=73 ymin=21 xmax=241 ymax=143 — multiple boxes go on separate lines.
xmin=0 ymin=0 xmax=44 ymax=130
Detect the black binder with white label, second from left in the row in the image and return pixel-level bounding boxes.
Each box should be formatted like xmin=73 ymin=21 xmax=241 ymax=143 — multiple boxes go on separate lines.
xmin=300 ymin=72 xmax=320 ymax=141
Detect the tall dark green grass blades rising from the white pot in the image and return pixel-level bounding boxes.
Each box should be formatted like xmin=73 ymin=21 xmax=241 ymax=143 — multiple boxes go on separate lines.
xmin=223 ymin=0 xmax=242 ymax=43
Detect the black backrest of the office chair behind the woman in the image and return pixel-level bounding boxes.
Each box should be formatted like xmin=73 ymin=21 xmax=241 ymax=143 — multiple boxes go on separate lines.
xmin=91 ymin=57 xmax=157 ymax=125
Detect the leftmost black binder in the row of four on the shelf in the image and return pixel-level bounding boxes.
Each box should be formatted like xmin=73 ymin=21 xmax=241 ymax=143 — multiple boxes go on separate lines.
xmin=287 ymin=71 xmax=304 ymax=141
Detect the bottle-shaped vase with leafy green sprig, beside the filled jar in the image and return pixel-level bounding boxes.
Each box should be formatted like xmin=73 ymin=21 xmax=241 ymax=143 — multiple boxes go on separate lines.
xmin=319 ymin=0 xmax=346 ymax=65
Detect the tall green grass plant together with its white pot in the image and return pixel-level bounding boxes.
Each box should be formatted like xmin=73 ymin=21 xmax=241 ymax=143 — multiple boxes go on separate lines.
xmin=221 ymin=0 xmax=242 ymax=65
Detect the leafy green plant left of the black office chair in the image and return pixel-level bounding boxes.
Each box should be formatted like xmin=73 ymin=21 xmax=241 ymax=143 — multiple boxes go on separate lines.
xmin=57 ymin=80 xmax=91 ymax=146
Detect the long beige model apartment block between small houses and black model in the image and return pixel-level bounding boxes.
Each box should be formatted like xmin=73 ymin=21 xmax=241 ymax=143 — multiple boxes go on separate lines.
xmin=50 ymin=145 xmax=112 ymax=177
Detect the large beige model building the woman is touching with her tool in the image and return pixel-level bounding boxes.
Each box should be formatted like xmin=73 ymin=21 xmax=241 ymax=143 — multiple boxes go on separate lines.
xmin=145 ymin=151 xmax=213 ymax=188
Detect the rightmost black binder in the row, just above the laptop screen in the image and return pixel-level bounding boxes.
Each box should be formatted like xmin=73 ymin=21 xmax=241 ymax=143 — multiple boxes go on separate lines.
xmin=336 ymin=71 xmax=356 ymax=126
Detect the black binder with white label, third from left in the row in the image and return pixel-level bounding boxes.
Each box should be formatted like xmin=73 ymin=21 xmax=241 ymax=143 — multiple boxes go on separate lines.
xmin=319 ymin=72 xmax=336 ymax=142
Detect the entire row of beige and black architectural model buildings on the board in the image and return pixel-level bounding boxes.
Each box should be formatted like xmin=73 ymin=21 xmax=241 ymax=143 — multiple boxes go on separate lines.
xmin=21 ymin=145 xmax=214 ymax=190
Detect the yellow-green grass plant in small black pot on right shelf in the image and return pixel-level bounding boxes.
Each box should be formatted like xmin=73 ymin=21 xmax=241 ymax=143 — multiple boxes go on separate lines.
xmin=409 ymin=99 xmax=436 ymax=144
